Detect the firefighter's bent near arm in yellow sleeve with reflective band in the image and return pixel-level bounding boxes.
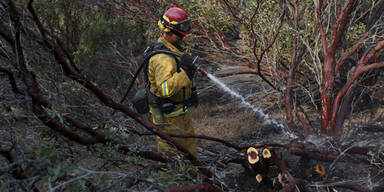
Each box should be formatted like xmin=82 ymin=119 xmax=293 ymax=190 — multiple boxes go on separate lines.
xmin=152 ymin=54 xmax=192 ymax=97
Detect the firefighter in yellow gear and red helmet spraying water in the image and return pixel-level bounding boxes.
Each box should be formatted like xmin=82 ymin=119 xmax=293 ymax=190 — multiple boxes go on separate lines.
xmin=147 ymin=7 xmax=198 ymax=157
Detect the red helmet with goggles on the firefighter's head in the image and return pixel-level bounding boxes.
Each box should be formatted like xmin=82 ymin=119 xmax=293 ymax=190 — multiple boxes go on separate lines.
xmin=158 ymin=7 xmax=192 ymax=35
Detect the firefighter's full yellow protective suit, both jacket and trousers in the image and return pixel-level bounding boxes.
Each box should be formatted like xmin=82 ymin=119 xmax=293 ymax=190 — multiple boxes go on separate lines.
xmin=148 ymin=38 xmax=198 ymax=157
